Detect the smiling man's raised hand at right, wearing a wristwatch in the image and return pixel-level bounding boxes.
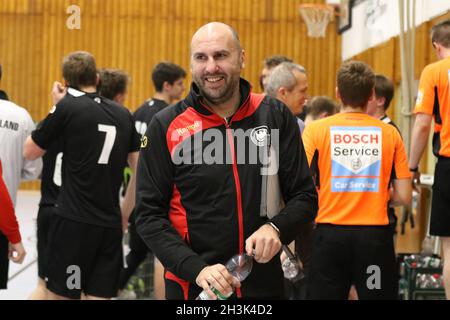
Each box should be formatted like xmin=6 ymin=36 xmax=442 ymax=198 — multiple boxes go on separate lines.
xmin=245 ymin=224 xmax=281 ymax=263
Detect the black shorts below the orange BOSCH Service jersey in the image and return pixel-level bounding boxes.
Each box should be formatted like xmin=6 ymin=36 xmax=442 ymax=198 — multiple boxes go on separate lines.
xmin=307 ymin=224 xmax=398 ymax=300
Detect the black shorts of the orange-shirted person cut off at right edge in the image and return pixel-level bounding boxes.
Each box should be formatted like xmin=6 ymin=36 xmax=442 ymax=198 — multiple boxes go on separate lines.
xmin=430 ymin=157 xmax=450 ymax=237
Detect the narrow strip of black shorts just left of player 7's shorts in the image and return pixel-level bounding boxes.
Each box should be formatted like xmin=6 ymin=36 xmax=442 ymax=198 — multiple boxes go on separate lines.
xmin=37 ymin=206 xmax=55 ymax=279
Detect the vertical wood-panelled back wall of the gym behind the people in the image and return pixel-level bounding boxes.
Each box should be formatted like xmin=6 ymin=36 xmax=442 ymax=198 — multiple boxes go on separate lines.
xmin=0 ymin=0 xmax=341 ymax=188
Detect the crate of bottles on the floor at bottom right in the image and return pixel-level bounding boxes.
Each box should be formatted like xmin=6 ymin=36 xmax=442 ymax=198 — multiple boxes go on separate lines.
xmin=400 ymin=255 xmax=445 ymax=300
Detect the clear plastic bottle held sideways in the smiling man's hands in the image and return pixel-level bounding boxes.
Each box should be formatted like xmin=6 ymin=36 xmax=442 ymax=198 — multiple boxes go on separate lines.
xmin=196 ymin=253 xmax=253 ymax=300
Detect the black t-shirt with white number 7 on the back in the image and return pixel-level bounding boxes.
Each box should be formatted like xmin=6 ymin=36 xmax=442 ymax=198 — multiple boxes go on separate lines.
xmin=32 ymin=88 xmax=140 ymax=228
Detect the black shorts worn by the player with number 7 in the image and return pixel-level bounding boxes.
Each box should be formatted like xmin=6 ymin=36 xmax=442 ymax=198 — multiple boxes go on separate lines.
xmin=45 ymin=214 xmax=123 ymax=299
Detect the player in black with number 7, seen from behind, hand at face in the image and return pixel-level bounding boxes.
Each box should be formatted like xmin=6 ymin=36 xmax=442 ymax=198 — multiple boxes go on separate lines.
xmin=24 ymin=52 xmax=140 ymax=299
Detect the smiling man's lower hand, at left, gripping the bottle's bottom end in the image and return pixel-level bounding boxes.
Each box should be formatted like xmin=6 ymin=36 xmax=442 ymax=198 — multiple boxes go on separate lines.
xmin=195 ymin=264 xmax=241 ymax=300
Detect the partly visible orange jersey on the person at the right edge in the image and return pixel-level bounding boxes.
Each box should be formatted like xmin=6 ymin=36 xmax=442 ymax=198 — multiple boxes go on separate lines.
xmin=414 ymin=57 xmax=450 ymax=157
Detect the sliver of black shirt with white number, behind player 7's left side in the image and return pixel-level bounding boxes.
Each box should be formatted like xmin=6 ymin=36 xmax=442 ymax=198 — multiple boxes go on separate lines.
xmin=39 ymin=138 xmax=63 ymax=206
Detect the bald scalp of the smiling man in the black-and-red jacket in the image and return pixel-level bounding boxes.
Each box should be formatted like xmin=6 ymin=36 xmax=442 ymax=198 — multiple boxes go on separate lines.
xmin=191 ymin=22 xmax=242 ymax=54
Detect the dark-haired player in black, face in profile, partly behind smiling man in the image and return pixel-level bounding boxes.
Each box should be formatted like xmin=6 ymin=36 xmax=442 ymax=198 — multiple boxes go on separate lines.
xmin=119 ymin=62 xmax=186 ymax=299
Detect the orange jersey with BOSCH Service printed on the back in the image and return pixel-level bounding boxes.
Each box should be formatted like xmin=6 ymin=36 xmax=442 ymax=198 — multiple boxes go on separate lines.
xmin=302 ymin=113 xmax=411 ymax=225
